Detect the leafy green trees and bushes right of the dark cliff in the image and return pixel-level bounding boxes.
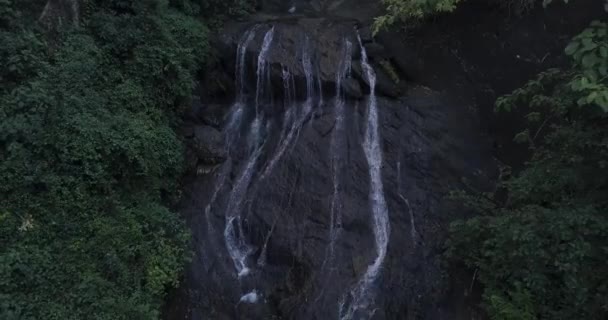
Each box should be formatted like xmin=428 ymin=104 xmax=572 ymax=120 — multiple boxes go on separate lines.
xmin=447 ymin=22 xmax=608 ymax=320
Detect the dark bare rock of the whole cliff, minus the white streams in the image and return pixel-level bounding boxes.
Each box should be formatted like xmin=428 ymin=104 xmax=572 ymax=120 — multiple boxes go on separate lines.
xmin=165 ymin=0 xmax=600 ymax=320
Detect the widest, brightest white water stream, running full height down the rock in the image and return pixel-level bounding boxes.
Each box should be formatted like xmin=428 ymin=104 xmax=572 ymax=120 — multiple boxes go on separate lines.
xmin=340 ymin=34 xmax=390 ymax=319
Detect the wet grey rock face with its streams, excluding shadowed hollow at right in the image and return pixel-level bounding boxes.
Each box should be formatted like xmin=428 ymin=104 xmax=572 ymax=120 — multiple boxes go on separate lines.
xmin=167 ymin=12 xmax=490 ymax=319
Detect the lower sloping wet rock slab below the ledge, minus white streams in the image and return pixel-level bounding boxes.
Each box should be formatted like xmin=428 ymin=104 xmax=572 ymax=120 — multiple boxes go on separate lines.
xmin=169 ymin=88 xmax=488 ymax=319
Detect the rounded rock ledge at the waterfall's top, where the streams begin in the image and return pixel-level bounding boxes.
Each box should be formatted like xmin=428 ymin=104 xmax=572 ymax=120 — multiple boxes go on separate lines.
xmin=216 ymin=16 xmax=407 ymax=99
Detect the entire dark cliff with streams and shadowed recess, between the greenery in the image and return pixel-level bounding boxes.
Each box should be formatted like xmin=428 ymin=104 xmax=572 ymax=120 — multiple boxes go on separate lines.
xmin=166 ymin=0 xmax=594 ymax=319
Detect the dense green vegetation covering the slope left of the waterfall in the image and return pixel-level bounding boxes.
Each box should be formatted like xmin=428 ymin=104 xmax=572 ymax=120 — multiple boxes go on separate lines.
xmin=0 ymin=0 xmax=226 ymax=320
